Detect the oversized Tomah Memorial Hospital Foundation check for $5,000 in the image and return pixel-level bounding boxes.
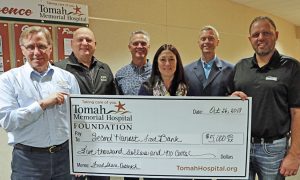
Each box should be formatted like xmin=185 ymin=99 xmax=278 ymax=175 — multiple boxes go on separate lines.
xmin=68 ymin=95 xmax=252 ymax=179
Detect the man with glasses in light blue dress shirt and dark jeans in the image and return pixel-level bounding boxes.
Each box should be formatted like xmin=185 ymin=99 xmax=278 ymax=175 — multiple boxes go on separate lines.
xmin=0 ymin=26 xmax=80 ymax=180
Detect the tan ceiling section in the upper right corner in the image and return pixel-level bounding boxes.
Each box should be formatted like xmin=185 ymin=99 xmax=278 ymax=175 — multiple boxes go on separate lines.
xmin=231 ymin=0 xmax=300 ymax=27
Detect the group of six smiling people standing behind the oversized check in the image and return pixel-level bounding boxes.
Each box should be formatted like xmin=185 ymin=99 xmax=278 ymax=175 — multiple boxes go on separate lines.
xmin=0 ymin=16 xmax=300 ymax=180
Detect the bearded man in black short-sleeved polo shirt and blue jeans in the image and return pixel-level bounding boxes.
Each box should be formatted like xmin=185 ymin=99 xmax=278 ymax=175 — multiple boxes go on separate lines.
xmin=232 ymin=16 xmax=300 ymax=180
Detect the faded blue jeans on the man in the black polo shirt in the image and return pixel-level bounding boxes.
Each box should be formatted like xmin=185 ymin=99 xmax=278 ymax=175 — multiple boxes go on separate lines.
xmin=249 ymin=137 xmax=288 ymax=180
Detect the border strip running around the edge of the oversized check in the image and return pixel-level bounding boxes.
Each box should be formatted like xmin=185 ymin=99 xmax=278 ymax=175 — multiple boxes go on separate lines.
xmin=68 ymin=95 xmax=252 ymax=179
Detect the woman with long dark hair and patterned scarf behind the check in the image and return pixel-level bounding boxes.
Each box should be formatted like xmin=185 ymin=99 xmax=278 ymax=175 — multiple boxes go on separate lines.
xmin=139 ymin=44 xmax=187 ymax=96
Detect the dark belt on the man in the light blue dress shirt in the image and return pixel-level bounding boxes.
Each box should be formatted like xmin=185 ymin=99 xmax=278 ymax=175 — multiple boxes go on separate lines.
xmin=14 ymin=141 xmax=68 ymax=154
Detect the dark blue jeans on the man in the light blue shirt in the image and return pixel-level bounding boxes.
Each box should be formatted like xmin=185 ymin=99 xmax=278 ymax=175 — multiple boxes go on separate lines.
xmin=11 ymin=143 xmax=72 ymax=180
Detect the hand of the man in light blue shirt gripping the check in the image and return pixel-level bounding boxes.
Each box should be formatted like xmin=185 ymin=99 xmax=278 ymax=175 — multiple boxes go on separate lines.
xmin=39 ymin=92 xmax=68 ymax=110
